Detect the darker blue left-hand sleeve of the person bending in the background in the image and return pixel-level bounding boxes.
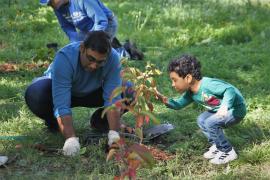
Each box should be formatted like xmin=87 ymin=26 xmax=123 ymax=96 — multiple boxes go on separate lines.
xmin=54 ymin=11 xmax=80 ymax=42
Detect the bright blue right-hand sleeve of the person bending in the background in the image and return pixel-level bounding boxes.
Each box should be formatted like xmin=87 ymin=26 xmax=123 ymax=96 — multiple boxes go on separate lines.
xmin=84 ymin=1 xmax=108 ymax=31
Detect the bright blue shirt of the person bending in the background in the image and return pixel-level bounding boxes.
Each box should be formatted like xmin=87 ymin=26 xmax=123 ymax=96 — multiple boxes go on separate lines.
xmin=54 ymin=0 xmax=113 ymax=42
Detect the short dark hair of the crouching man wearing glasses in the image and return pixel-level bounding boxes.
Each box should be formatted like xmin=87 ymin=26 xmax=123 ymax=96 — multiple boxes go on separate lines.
xmin=83 ymin=31 xmax=111 ymax=54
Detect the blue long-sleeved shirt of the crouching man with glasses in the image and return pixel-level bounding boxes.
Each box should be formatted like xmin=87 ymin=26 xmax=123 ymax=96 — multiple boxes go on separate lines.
xmin=45 ymin=42 xmax=122 ymax=117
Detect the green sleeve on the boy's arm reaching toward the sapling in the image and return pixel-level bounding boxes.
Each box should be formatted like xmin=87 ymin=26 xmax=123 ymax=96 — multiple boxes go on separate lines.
xmin=166 ymin=92 xmax=193 ymax=110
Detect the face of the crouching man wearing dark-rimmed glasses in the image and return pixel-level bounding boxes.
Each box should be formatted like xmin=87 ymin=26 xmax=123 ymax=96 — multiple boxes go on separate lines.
xmin=80 ymin=44 xmax=107 ymax=71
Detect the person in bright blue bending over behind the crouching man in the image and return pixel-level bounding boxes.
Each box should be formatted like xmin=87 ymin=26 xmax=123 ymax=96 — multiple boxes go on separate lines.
xmin=40 ymin=0 xmax=118 ymax=42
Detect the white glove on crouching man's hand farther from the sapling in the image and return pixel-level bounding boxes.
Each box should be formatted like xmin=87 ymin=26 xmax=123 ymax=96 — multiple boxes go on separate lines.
xmin=63 ymin=137 xmax=80 ymax=156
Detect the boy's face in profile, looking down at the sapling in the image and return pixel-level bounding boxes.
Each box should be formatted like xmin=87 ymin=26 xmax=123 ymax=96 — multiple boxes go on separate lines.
xmin=170 ymin=72 xmax=192 ymax=93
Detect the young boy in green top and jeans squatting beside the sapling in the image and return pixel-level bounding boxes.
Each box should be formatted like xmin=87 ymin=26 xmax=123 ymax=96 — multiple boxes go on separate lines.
xmin=156 ymin=55 xmax=246 ymax=164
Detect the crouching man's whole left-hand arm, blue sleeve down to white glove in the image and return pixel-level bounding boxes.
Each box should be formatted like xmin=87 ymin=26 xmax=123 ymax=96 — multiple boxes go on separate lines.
xmin=52 ymin=52 xmax=80 ymax=156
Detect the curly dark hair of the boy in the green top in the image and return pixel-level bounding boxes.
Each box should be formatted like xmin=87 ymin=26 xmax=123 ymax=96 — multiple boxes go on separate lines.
xmin=168 ymin=54 xmax=202 ymax=80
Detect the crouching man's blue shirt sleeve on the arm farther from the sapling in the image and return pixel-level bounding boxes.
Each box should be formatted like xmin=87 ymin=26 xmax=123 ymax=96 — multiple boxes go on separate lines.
xmin=52 ymin=53 xmax=73 ymax=118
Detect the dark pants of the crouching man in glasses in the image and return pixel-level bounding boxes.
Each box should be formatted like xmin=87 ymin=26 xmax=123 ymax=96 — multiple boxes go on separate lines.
xmin=25 ymin=77 xmax=108 ymax=131
